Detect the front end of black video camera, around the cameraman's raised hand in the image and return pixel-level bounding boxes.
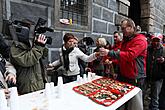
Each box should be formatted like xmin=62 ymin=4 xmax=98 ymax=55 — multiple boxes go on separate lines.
xmin=34 ymin=18 xmax=54 ymax=45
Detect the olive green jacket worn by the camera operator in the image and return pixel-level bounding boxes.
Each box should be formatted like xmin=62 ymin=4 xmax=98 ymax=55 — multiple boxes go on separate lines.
xmin=10 ymin=41 xmax=45 ymax=94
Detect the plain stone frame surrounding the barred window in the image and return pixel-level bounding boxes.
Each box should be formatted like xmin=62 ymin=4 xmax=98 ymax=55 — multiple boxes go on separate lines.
xmin=54 ymin=0 xmax=92 ymax=32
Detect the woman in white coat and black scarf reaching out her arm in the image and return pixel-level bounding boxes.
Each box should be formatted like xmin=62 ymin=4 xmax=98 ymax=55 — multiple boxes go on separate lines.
xmin=49 ymin=33 xmax=99 ymax=83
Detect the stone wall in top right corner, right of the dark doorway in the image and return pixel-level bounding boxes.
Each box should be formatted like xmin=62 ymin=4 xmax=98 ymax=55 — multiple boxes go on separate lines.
xmin=141 ymin=0 xmax=165 ymax=33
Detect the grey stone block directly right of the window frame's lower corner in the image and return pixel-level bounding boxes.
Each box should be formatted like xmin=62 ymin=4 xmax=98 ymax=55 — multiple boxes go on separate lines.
xmin=93 ymin=20 xmax=107 ymax=34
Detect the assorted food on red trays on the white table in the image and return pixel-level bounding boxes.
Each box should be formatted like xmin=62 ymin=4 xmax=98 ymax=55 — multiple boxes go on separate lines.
xmin=73 ymin=78 xmax=135 ymax=106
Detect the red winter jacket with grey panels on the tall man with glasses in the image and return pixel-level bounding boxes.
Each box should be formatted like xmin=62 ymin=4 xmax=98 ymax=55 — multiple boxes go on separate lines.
xmin=119 ymin=34 xmax=147 ymax=79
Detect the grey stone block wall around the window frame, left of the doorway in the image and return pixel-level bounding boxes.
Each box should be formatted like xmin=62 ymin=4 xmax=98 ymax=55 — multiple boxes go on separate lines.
xmin=0 ymin=0 xmax=122 ymax=61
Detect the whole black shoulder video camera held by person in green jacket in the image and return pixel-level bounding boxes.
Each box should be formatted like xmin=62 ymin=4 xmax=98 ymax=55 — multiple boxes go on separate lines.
xmin=2 ymin=18 xmax=54 ymax=45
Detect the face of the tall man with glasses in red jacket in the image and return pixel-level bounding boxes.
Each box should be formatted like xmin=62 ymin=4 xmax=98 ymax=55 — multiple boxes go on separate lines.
xmin=121 ymin=21 xmax=134 ymax=37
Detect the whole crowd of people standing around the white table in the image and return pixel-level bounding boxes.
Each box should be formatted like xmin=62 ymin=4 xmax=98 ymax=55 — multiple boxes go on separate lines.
xmin=0 ymin=18 xmax=165 ymax=110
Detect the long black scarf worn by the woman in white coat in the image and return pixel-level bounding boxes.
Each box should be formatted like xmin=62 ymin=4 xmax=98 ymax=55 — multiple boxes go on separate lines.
xmin=62 ymin=45 xmax=74 ymax=71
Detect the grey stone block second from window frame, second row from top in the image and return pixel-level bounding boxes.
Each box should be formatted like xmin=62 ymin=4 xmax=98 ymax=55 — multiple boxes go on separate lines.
xmin=103 ymin=9 xmax=114 ymax=22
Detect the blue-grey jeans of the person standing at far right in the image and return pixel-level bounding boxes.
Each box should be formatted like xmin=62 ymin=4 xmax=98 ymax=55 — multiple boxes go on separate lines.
xmin=149 ymin=79 xmax=163 ymax=110
